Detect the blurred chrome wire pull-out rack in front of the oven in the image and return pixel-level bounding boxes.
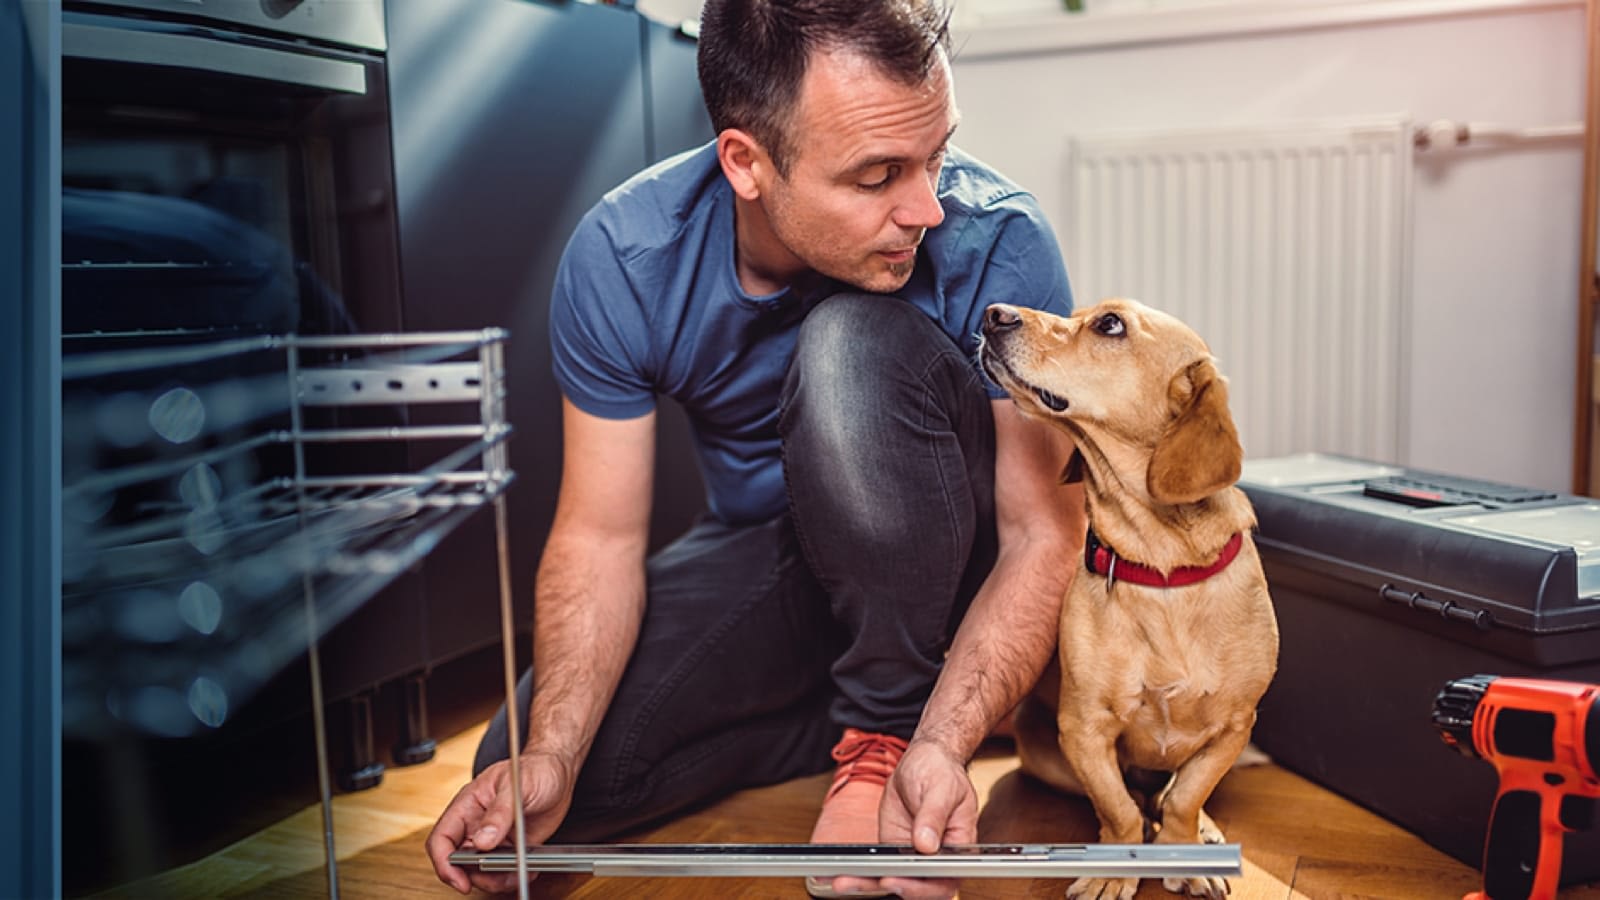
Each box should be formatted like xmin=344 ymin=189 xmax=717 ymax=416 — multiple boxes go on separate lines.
xmin=62 ymin=328 xmax=514 ymax=737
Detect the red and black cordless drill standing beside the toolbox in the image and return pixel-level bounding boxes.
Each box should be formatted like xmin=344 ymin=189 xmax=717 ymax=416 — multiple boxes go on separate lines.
xmin=1434 ymin=676 xmax=1600 ymax=900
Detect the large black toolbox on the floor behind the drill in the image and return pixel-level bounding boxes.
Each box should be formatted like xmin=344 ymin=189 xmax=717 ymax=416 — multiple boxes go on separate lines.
xmin=1240 ymin=453 xmax=1600 ymax=884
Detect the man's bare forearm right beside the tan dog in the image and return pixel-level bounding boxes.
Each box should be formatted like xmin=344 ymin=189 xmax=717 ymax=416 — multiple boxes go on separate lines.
xmin=912 ymin=538 xmax=1075 ymax=761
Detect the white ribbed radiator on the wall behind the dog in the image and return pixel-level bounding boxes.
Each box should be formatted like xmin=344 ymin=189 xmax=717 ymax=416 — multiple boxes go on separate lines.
xmin=1061 ymin=119 xmax=1413 ymax=461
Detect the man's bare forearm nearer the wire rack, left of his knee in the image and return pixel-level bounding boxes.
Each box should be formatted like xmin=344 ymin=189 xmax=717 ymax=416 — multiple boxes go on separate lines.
xmin=523 ymin=536 xmax=645 ymax=772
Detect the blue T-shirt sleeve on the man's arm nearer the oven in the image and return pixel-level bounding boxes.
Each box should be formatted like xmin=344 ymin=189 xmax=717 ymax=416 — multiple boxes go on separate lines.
xmin=550 ymin=208 xmax=656 ymax=420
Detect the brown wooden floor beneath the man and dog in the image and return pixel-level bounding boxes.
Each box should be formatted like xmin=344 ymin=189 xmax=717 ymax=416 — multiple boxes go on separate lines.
xmin=104 ymin=725 xmax=1600 ymax=900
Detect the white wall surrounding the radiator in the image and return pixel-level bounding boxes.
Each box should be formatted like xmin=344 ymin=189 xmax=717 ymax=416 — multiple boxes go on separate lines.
xmin=955 ymin=0 xmax=1586 ymax=490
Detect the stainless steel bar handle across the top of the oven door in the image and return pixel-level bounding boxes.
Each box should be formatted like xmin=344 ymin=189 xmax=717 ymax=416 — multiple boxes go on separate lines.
xmin=61 ymin=22 xmax=366 ymax=94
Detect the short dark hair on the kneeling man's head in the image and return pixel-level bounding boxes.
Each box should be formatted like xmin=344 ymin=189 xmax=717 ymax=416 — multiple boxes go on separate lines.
xmin=698 ymin=0 xmax=950 ymax=175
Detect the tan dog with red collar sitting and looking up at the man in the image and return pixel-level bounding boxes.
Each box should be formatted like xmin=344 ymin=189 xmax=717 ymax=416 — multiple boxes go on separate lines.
xmin=979 ymin=299 xmax=1278 ymax=900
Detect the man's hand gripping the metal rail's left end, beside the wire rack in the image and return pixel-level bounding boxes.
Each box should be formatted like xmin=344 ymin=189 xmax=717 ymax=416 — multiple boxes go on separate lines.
xmin=427 ymin=753 xmax=578 ymax=894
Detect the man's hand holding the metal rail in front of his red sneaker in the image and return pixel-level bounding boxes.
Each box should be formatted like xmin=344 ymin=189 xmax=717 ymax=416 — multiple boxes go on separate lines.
xmin=834 ymin=738 xmax=978 ymax=900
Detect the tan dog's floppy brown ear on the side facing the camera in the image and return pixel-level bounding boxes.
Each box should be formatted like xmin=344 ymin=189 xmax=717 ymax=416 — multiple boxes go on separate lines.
xmin=1146 ymin=357 xmax=1245 ymax=504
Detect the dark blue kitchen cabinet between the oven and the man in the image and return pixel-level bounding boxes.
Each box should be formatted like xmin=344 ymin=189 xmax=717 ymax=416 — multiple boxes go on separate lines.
xmin=360 ymin=0 xmax=712 ymax=693
